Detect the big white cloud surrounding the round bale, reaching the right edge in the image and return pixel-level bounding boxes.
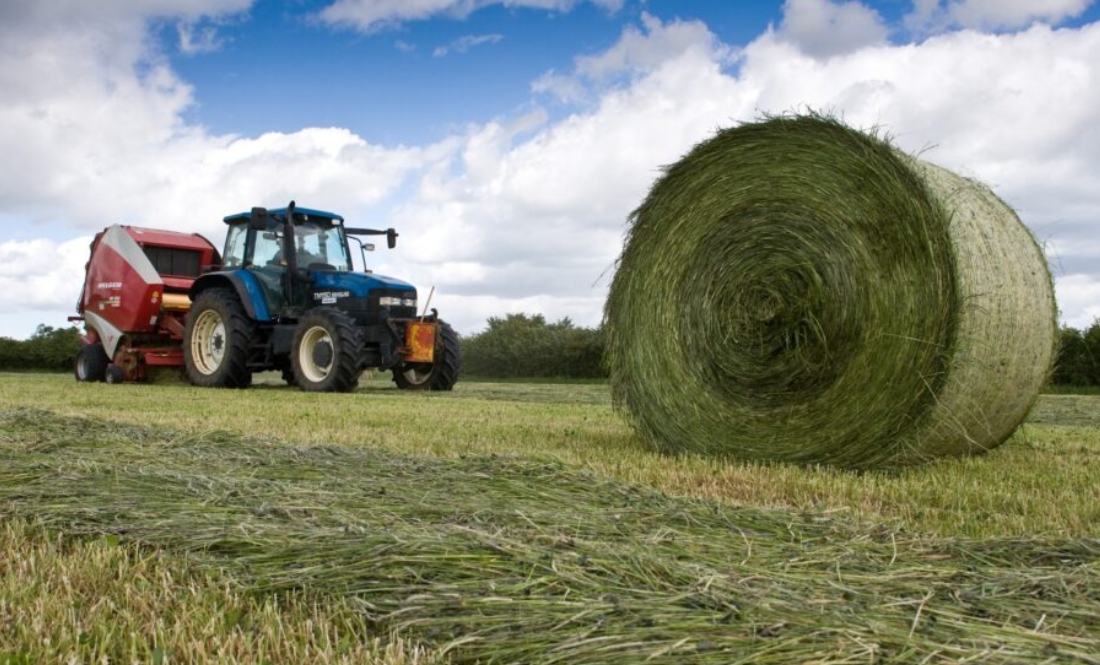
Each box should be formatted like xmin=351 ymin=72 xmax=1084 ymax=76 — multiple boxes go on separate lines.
xmin=396 ymin=12 xmax=1100 ymax=334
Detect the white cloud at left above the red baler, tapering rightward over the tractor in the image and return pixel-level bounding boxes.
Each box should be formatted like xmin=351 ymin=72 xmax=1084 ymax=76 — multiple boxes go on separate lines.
xmin=0 ymin=0 xmax=453 ymax=335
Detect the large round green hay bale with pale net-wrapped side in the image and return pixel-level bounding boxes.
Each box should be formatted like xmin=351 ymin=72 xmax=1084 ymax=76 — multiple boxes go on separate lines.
xmin=604 ymin=115 xmax=1057 ymax=468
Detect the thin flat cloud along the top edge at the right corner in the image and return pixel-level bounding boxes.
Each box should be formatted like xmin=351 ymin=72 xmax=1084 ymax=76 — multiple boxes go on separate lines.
xmin=905 ymin=0 xmax=1093 ymax=31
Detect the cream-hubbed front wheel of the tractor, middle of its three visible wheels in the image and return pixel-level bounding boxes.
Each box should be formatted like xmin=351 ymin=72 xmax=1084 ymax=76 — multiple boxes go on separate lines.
xmin=290 ymin=307 xmax=363 ymax=392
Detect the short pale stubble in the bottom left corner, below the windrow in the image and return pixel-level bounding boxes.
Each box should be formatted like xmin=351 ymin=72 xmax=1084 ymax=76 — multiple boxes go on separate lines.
xmin=0 ymin=519 xmax=440 ymax=665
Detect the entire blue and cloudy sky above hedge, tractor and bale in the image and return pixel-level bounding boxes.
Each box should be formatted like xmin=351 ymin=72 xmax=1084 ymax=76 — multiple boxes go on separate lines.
xmin=0 ymin=0 xmax=1100 ymax=337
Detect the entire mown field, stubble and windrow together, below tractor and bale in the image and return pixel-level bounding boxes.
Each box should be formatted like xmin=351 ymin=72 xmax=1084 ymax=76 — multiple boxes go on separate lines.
xmin=0 ymin=374 xmax=1100 ymax=664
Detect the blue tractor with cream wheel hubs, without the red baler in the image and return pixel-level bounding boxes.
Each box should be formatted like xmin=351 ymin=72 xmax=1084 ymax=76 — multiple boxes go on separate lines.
xmin=184 ymin=201 xmax=462 ymax=392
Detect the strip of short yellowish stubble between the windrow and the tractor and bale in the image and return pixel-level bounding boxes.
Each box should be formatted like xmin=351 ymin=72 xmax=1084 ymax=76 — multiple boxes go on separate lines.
xmin=0 ymin=375 xmax=1100 ymax=537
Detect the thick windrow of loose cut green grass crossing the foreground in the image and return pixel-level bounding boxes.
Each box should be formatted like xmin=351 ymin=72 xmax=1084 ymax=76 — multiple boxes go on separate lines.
xmin=0 ymin=410 xmax=1100 ymax=664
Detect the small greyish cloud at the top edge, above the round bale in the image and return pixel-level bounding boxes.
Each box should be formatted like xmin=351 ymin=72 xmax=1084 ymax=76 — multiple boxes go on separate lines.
xmin=778 ymin=0 xmax=889 ymax=58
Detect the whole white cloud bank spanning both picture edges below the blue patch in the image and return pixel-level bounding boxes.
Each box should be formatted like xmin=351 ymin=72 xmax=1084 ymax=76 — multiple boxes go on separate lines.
xmin=0 ymin=0 xmax=1100 ymax=334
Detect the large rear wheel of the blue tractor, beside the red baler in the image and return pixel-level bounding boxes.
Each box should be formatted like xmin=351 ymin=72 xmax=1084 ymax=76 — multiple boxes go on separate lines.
xmin=184 ymin=289 xmax=256 ymax=388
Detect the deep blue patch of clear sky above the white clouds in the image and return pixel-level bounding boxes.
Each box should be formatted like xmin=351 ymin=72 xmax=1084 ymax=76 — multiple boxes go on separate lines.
xmin=157 ymin=0 xmax=781 ymax=144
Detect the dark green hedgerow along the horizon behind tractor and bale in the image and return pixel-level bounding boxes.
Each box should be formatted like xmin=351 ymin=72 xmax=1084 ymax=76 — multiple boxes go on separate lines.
xmin=8 ymin=313 xmax=1100 ymax=387
